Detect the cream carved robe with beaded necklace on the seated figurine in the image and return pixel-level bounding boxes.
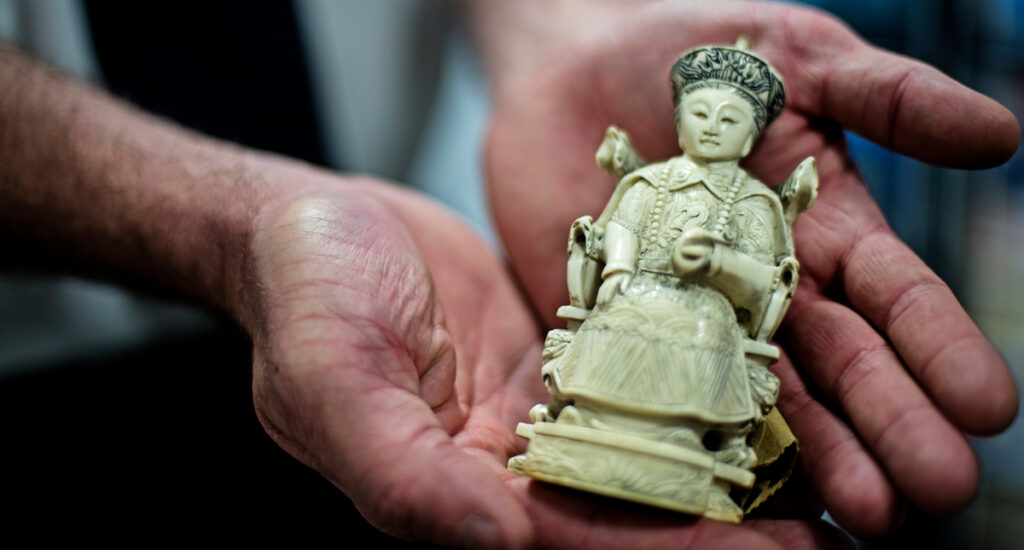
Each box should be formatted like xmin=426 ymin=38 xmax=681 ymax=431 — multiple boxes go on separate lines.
xmin=551 ymin=158 xmax=793 ymax=425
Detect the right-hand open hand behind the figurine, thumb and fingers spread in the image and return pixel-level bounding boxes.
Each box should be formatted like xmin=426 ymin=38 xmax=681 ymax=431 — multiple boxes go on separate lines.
xmin=486 ymin=1 xmax=1020 ymax=536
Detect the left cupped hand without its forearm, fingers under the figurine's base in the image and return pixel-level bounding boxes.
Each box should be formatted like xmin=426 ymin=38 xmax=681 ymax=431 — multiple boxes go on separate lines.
xmin=239 ymin=167 xmax=843 ymax=549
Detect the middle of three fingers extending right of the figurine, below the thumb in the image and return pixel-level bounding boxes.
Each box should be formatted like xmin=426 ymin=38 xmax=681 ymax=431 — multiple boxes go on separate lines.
xmin=782 ymin=281 xmax=978 ymax=513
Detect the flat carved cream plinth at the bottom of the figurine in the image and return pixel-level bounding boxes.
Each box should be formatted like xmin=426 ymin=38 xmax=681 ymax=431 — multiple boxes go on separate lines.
xmin=508 ymin=422 xmax=754 ymax=523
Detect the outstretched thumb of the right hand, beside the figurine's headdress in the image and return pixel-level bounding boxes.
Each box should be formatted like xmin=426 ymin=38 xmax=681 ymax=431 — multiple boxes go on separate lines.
xmin=753 ymin=5 xmax=1020 ymax=168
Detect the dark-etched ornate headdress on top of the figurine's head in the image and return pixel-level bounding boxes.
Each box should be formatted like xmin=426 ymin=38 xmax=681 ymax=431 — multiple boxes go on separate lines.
xmin=669 ymin=41 xmax=785 ymax=133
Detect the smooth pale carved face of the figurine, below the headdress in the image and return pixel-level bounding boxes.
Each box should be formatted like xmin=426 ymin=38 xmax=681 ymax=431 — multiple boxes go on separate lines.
xmin=676 ymin=88 xmax=754 ymax=162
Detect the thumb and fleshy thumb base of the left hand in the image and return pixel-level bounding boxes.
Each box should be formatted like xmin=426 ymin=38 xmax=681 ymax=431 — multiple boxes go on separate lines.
xmin=253 ymin=197 xmax=532 ymax=548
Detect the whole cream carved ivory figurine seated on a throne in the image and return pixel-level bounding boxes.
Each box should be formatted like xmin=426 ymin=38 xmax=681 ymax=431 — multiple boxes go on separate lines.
xmin=509 ymin=40 xmax=817 ymax=521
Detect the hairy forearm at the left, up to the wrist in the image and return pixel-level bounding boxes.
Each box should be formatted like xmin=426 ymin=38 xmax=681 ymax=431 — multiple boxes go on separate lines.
xmin=0 ymin=46 xmax=288 ymax=313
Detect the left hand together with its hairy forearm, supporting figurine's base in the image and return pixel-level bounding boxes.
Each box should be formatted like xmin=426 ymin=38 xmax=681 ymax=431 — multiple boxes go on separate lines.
xmin=0 ymin=35 xmax=837 ymax=548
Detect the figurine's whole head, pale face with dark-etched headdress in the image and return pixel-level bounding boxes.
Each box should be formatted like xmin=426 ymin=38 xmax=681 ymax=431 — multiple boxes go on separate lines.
xmin=671 ymin=46 xmax=785 ymax=161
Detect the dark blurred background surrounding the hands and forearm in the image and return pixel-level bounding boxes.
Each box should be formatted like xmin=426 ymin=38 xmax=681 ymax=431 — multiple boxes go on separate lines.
xmin=0 ymin=0 xmax=1024 ymax=549
